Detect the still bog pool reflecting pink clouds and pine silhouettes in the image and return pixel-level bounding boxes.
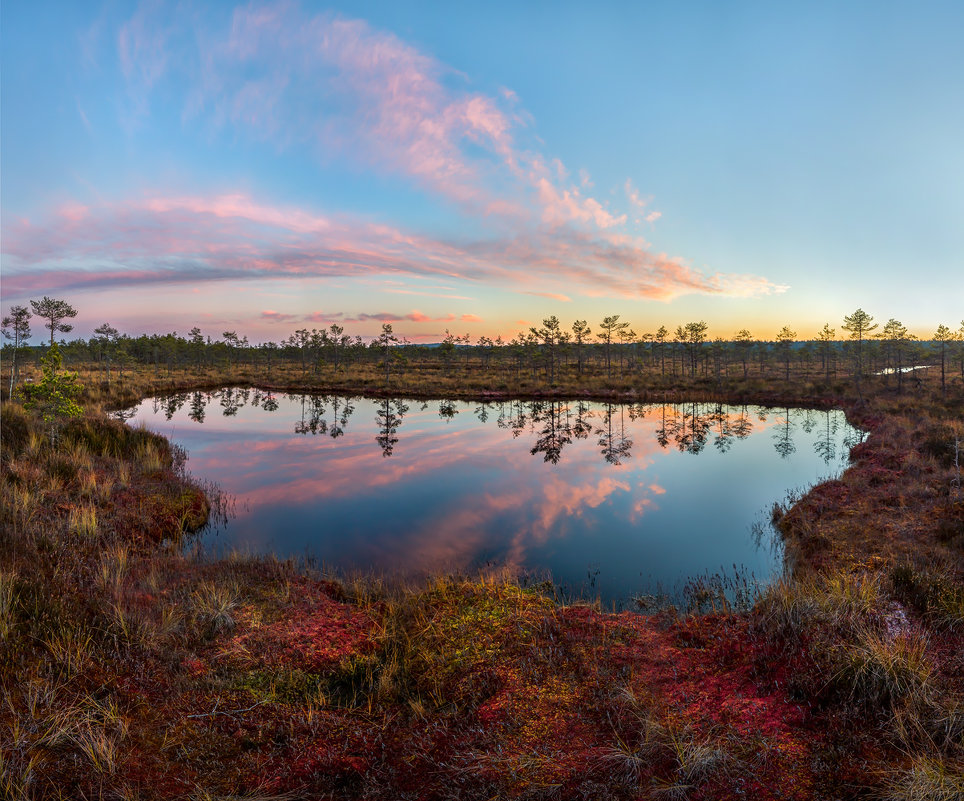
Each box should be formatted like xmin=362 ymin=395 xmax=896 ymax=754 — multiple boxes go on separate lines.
xmin=124 ymin=389 xmax=860 ymax=601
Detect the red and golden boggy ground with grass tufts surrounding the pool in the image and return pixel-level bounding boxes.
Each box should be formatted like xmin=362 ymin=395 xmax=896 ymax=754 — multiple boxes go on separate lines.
xmin=0 ymin=367 xmax=964 ymax=799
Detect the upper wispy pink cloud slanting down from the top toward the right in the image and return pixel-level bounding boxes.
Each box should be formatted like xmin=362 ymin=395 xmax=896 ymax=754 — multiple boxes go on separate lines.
xmin=130 ymin=2 xmax=664 ymax=236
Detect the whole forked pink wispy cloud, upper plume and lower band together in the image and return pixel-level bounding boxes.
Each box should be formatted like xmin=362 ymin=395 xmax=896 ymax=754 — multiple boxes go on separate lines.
xmin=2 ymin=2 xmax=784 ymax=308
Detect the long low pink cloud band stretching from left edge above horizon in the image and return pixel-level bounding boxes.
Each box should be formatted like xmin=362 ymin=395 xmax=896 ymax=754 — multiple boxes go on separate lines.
xmin=2 ymin=194 xmax=783 ymax=304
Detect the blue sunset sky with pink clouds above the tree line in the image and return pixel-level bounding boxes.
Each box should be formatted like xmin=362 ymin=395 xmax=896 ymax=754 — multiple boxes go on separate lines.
xmin=0 ymin=0 xmax=964 ymax=342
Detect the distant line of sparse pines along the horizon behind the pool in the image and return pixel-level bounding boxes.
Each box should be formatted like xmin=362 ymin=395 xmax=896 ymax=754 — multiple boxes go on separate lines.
xmin=2 ymin=297 xmax=964 ymax=392
